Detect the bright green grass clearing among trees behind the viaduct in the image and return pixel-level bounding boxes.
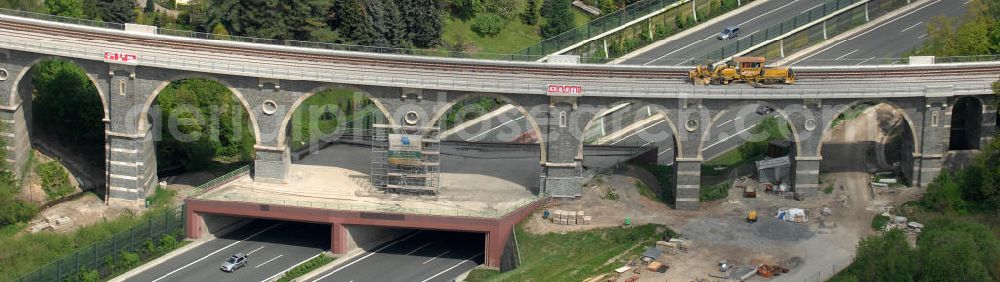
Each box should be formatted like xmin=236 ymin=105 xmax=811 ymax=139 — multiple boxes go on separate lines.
xmin=441 ymin=1 xmax=591 ymax=54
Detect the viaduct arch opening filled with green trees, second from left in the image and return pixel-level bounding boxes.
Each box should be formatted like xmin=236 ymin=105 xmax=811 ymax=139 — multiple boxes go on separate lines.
xmin=150 ymin=76 xmax=257 ymax=189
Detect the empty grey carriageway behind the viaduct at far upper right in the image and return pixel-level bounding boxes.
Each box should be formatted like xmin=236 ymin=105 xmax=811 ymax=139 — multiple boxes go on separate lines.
xmin=789 ymin=0 xmax=969 ymax=66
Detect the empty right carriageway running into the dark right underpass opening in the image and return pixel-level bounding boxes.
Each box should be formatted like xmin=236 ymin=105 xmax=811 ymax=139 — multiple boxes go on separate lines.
xmin=312 ymin=231 xmax=485 ymax=282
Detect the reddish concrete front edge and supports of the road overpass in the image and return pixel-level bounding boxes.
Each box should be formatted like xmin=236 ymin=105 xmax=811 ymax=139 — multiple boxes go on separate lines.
xmin=184 ymin=199 xmax=547 ymax=267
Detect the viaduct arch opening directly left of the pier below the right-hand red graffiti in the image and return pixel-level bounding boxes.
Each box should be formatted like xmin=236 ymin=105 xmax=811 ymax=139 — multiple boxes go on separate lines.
xmin=427 ymin=93 xmax=544 ymax=196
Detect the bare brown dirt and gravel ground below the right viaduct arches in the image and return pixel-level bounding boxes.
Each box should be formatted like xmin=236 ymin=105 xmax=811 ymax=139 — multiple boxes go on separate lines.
xmin=526 ymin=105 xmax=923 ymax=281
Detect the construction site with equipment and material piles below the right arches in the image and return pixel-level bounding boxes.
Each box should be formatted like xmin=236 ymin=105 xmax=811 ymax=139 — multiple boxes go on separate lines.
xmin=524 ymin=104 xmax=925 ymax=281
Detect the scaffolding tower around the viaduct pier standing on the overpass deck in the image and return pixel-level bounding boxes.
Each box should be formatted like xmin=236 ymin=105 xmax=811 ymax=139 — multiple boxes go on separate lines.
xmin=370 ymin=124 xmax=441 ymax=195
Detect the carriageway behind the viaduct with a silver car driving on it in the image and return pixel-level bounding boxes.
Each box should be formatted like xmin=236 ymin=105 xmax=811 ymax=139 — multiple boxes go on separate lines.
xmin=622 ymin=0 xmax=823 ymax=65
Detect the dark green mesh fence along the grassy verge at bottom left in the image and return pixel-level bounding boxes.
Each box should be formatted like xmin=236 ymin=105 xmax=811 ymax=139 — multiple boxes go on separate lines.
xmin=9 ymin=206 xmax=184 ymax=282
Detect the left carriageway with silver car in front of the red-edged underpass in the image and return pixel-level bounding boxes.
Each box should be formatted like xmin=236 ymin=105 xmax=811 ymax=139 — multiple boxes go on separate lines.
xmin=127 ymin=220 xmax=330 ymax=282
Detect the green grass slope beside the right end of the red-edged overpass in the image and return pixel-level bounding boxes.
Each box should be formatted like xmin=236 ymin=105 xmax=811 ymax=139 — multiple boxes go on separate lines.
xmin=467 ymin=224 xmax=672 ymax=281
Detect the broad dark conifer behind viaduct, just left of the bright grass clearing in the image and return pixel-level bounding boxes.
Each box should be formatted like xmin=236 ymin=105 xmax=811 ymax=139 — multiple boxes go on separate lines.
xmin=399 ymin=0 xmax=444 ymax=48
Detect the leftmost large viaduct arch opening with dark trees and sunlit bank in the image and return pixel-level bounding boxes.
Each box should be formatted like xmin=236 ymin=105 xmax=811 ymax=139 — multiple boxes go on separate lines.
xmin=11 ymin=59 xmax=107 ymax=203
